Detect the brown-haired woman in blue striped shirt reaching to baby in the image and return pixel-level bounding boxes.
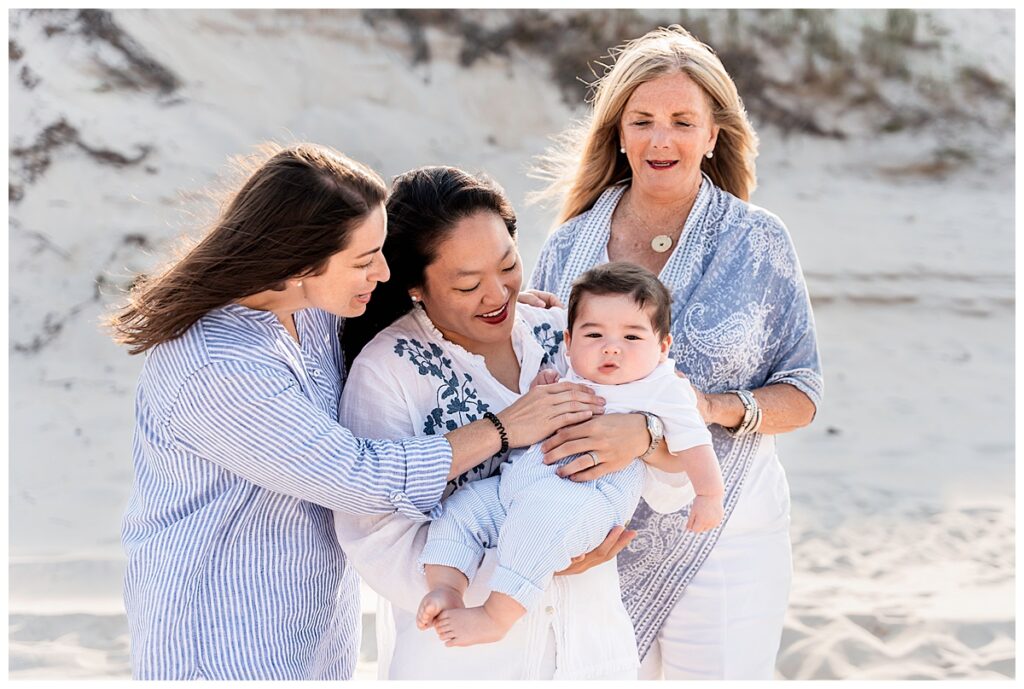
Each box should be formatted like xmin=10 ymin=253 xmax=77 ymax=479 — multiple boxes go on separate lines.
xmin=110 ymin=144 xmax=600 ymax=680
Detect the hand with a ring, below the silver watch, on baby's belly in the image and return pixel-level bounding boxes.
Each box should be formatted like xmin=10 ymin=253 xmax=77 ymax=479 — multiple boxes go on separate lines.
xmin=541 ymin=414 xmax=650 ymax=481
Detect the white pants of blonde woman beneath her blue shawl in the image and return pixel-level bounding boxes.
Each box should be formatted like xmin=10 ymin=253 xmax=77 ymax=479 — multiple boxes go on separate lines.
xmin=640 ymin=446 xmax=793 ymax=680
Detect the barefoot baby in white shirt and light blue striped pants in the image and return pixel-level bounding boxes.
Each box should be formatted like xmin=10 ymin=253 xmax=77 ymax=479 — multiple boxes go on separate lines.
xmin=417 ymin=263 xmax=724 ymax=646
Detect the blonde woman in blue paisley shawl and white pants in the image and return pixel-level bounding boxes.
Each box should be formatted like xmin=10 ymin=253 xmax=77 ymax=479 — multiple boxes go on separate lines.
xmin=530 ymin=26 xmax=822 ymax=679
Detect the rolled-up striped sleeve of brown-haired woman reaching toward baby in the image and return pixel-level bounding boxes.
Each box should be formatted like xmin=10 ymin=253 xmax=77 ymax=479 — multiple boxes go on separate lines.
xmin=166 ymin=361 xmax=452 ymax=521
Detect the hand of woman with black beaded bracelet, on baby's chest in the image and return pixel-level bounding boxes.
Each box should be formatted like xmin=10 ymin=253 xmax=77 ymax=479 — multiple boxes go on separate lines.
xmin=498 ymin=382 xmax=604 ymax=447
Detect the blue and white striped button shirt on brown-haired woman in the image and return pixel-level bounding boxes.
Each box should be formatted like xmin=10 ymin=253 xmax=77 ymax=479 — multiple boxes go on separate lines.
xmin=123 ymin=304 xmax=452 ymax=680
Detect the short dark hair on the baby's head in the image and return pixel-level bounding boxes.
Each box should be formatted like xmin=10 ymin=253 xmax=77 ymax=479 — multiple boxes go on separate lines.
xmin=568 ymin=261 xmax=672 ymax=338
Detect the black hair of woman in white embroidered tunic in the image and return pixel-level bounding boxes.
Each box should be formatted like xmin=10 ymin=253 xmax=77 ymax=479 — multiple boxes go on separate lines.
xmin=341 ymin=166 xmax=516 ymax=361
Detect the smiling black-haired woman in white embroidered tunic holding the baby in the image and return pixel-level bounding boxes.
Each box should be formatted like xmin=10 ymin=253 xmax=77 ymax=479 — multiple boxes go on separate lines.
xmin=335 ymin=168 xmax=688 ymax=680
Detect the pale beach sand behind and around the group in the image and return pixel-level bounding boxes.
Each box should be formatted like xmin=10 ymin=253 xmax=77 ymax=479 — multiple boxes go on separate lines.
xmin=8 ymin=12 xmax=1016 ymax=680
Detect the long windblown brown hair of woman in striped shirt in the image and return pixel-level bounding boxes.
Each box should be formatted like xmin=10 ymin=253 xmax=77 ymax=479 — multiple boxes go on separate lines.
xmin=106 ymin=143 xmax=387 ymax=354
